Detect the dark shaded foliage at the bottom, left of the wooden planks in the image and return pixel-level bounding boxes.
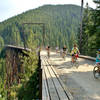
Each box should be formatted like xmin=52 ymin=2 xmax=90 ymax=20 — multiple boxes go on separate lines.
xmin=18 ymin=68 xmax=39 ymax=100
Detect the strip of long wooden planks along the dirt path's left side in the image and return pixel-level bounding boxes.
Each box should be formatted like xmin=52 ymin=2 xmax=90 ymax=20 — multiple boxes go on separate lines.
xmin=41 ymin=56 xmax=73 ymax=100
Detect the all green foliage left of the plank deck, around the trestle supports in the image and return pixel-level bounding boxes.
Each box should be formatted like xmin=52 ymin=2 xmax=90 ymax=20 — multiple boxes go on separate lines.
xmin=0 ymin=40 xmax=39 ymax=100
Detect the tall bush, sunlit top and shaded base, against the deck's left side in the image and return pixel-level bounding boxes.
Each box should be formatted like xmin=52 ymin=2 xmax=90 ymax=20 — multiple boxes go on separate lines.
xmin=17 ymin=52 xmax=39 ymax=100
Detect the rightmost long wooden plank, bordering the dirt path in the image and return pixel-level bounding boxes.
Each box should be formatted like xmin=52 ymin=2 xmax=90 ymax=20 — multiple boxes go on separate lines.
xmin=46 ymin=59 xmax=68 ymax=100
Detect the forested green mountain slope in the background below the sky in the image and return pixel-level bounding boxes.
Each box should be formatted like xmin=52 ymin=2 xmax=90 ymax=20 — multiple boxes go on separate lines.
xmin=0 ymin=5 xmax=80 ymax=48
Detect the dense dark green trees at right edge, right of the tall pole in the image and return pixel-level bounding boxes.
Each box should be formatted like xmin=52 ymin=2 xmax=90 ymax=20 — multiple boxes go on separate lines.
xmin=77 ymin=0 xmax=100 ymax=57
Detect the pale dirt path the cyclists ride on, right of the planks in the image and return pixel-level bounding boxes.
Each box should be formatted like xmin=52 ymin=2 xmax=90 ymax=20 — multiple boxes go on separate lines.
xmin=41 ymin=51 xmax=100 ymax=100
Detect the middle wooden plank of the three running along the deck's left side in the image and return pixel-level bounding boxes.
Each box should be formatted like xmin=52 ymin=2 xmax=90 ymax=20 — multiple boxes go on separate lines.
xmin=42 ymin=59 xmax=60 ymax=100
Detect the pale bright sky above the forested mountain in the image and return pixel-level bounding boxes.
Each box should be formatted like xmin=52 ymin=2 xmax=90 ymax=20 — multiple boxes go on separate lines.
xmin=0 ymin=0 xmax=96 ymax=22
